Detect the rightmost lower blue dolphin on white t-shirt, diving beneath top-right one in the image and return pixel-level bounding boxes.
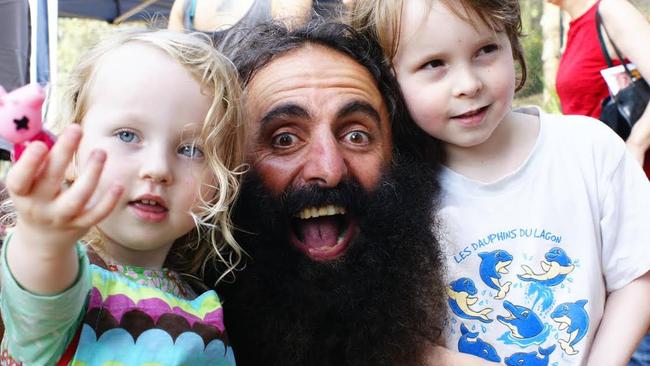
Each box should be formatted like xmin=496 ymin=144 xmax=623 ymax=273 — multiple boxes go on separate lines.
xmin=551 ymin=300 xmax=589 ymax=355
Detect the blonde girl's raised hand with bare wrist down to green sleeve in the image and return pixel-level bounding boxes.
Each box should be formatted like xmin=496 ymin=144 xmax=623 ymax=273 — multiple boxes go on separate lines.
xmin=6 ymin=125 xmax=122 ymax=295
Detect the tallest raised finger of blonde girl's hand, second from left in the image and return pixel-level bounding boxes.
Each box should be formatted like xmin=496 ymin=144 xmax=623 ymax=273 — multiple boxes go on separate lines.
xmin=34 ymin=125 xmax=81 ymax=197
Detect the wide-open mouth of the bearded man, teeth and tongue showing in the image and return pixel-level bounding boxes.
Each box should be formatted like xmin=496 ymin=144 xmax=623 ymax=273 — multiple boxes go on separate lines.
xmin=291 ymin=205 xmax=356 ymax=261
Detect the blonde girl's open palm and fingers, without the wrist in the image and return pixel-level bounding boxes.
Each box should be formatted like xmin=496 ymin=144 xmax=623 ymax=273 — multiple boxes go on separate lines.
xmin=7 ymin=125 xmax=122 ymax=246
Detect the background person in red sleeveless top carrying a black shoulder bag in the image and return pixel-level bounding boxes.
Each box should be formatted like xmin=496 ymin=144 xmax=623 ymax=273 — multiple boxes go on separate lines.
xmin=547 ymin=0 xmax=650 ymax=177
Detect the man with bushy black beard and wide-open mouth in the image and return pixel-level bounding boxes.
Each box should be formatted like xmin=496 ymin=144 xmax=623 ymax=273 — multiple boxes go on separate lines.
xmin=208 ymin=22 xmax=446 ymax=366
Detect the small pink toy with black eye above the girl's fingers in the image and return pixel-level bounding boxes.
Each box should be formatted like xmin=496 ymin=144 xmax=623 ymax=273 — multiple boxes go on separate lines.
xmin=0 ymin=84 xmax=55 ymax=161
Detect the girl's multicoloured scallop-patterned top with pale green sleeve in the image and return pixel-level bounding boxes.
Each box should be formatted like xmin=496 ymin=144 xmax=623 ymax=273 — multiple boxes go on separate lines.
xmin=0 ymin=245 xmax=235 ymax=366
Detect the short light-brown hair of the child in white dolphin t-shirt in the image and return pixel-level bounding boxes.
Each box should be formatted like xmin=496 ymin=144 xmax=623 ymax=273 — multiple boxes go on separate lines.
xmin=347 ymin=0 xmax=527 ymax=90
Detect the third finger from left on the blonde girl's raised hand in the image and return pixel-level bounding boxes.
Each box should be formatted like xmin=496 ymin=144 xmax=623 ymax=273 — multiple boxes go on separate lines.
xmin=55 ymin=150 xmax=106 ymax=222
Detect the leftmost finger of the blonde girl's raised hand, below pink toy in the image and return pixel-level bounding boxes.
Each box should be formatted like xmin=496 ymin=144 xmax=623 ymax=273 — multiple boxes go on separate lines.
xmin=5 ymin=141 xmax=47 ymax=196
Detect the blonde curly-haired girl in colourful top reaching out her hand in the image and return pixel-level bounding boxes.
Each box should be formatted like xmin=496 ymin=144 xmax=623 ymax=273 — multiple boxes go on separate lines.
xmin=0 ymin=30 xmax=244 ymax=365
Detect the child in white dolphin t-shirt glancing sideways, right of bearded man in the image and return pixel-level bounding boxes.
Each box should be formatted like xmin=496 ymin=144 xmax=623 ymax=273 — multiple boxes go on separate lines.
xmin=352 ymin=0 xmax=650 ymax=365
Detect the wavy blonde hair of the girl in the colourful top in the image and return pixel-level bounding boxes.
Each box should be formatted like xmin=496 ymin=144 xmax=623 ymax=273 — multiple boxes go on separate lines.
xmin=53 ymin=30 xmax=245 ymax=284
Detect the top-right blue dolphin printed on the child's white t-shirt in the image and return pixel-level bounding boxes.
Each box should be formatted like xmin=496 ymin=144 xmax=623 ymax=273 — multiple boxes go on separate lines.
xmin=517 ymin=247 xmax=575 ymax=286
